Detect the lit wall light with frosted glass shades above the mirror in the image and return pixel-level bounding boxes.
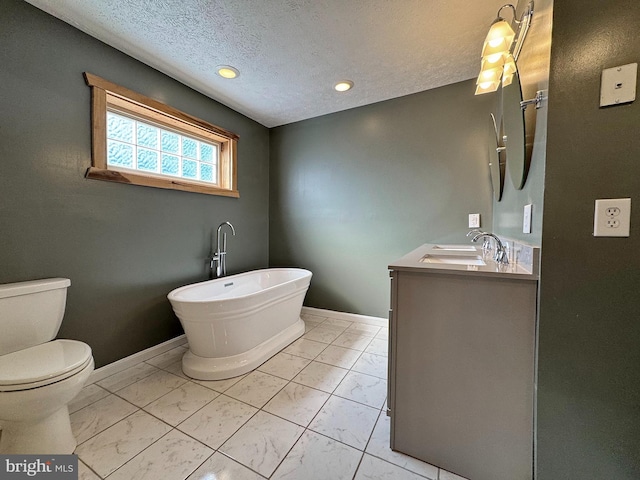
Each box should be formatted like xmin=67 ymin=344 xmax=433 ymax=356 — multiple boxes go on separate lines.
xmin=476 ymin=0 xmax=533 ymax=95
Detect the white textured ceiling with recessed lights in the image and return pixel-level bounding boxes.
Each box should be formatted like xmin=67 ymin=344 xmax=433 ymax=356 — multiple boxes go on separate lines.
xmin=27 ymin=0 xmax=503 ymax=127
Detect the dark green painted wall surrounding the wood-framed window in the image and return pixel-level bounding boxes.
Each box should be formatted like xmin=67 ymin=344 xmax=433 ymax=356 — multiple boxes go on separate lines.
xmin=0 ymin=0 xmax=269 ymax=366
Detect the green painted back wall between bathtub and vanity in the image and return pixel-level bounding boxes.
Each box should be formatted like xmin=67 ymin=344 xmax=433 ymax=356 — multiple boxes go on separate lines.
xmin=269 ymin=81 xmax=492 ymax=317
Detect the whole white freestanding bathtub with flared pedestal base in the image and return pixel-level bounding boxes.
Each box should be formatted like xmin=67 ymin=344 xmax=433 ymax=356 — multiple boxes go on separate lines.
xmin=167 ymin=268 xmax=311 ymax=380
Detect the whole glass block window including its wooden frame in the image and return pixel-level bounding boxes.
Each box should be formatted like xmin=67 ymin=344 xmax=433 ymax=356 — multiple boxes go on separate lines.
xmin=84 ymin=72 xmax=240 ymax=197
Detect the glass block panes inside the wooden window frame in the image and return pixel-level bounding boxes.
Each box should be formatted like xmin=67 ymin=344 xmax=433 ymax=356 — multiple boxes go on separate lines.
xmin=107 ymin=111 xmax=219 ymax=184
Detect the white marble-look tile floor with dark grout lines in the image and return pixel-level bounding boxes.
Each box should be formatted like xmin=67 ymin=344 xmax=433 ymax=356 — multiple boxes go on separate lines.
xmin=70 ymin=315 xmax=464 ymax=480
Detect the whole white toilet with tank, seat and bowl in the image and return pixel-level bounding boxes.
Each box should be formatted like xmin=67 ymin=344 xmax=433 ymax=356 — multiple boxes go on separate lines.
xmin=0 ymin=278 xmax=94 ymax=454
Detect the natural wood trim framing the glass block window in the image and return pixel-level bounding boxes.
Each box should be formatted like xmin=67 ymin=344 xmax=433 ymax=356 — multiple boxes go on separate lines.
xmin=83 ymin=72 xmax=240 ymax=198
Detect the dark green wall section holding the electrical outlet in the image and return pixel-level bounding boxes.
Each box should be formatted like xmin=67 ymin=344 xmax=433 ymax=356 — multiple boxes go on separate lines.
xmin=537 ymin=0 xmax=640 ymax=480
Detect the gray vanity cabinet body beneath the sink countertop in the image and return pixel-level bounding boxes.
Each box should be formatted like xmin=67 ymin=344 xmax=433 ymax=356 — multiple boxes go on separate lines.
xmin=388 ymin=265 xmax=537 ymax=480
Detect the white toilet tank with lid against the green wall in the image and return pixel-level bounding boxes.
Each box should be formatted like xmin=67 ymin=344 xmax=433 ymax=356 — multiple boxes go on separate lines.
xmin=0 ymin=278 xmax=71 ymax=355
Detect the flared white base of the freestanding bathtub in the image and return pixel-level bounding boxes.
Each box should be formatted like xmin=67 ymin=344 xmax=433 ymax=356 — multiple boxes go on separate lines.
xmin=182 ymin=317 xmax=305 ymax=380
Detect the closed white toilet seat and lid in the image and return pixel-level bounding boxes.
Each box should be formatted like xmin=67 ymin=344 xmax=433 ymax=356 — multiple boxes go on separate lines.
xmin=0 ymin=340 xmax=92 ymax=392
